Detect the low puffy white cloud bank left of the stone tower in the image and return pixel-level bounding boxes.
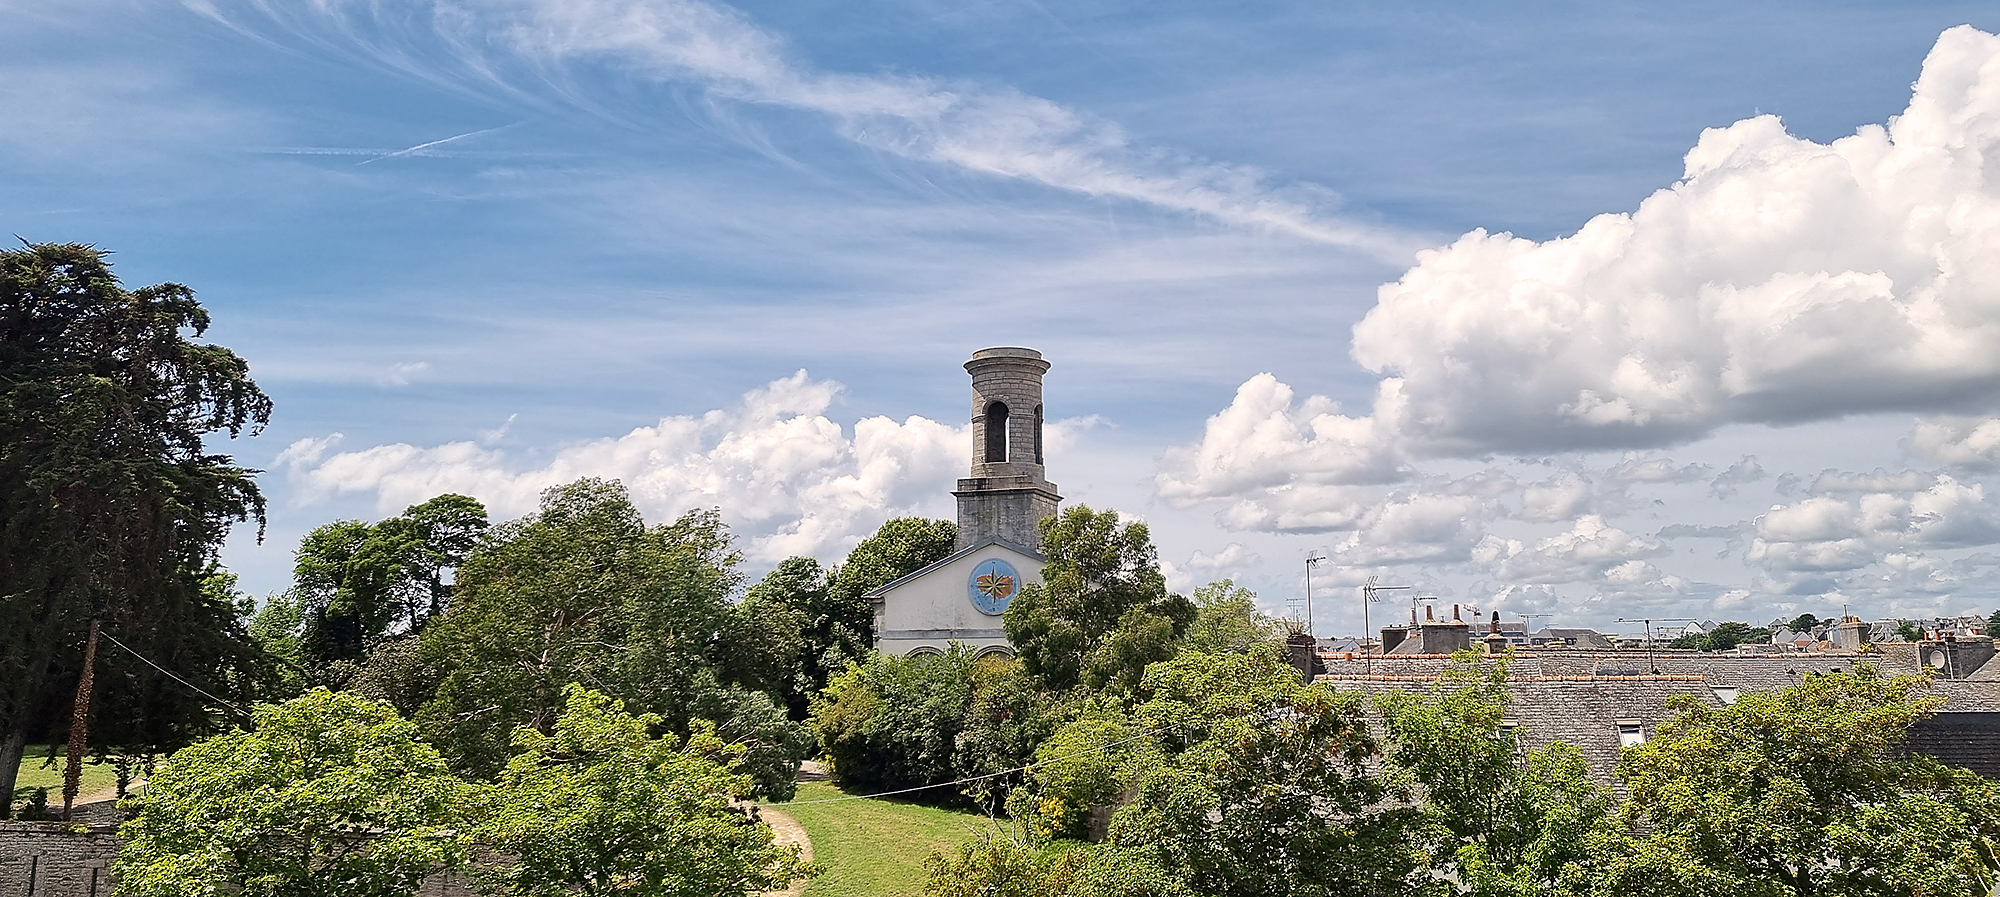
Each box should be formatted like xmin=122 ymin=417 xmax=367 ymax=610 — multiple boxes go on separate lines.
xmin=274 ymin=370 xmax=964 ymax=561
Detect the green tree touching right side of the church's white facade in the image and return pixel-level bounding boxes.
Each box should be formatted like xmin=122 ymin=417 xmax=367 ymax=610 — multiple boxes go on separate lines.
xmin=1006 ymin=505 xmax=1196 ymax=693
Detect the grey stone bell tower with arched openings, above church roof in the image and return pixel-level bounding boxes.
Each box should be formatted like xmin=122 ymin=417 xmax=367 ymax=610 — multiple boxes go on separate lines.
xmin=952 ymin=346 xmax=1062 ymax=551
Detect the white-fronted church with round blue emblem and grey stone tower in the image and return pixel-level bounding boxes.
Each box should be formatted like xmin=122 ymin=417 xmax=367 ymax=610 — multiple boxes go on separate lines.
xmin=868 ymin=346 xmax=1062 ymax=655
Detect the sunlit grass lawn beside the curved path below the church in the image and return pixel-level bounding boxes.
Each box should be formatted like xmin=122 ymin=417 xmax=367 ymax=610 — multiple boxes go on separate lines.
xmin=772 ymin=781 xmax=992 ymax=897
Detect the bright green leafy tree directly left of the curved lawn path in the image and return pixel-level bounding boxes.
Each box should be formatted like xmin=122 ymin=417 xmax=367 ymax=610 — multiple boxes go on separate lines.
xmin=478 ymin=685 xmax=812 ymax=897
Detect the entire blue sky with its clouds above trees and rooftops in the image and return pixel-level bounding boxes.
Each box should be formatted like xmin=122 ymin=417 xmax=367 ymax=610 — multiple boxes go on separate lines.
xmin=11 ymin=0 xmax=2000 ymax=633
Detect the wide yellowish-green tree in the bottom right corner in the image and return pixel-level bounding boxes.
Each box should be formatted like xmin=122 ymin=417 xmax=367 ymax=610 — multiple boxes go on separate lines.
xmin=1590 ymin=665 xmax=2000 ymax=897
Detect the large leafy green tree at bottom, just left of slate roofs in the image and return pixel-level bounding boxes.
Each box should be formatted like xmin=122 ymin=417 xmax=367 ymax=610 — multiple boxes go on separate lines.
xmin=1110 ymin=649 xmax=1422 ymax=897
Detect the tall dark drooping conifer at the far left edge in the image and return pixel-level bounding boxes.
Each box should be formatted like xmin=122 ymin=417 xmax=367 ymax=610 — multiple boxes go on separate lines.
xmin=0 ymin=244 xmax=270 ymax=819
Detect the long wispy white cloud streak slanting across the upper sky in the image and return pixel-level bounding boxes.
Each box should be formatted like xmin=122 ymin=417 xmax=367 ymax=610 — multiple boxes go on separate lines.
xmin=219 ymin=0 xmax=1420 ymax=262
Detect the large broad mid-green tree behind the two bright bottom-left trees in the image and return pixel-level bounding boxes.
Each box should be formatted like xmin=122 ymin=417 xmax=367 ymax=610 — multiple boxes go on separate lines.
xmin=416 ymin=479 xmax=810 ymax=799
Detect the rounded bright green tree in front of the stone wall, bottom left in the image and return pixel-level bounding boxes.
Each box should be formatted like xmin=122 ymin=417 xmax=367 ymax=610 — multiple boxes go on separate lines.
xmin=114 ymin=689 xmax=472 ymax=897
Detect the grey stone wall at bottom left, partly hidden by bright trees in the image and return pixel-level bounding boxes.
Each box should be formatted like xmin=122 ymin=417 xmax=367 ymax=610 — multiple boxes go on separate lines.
xmin=0 ymin=823 xmax=474 ymax=897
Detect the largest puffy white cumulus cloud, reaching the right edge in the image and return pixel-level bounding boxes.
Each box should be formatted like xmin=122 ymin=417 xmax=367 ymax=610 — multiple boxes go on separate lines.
xmin=1328 ymin=26 xmax=2000 ymax=455
